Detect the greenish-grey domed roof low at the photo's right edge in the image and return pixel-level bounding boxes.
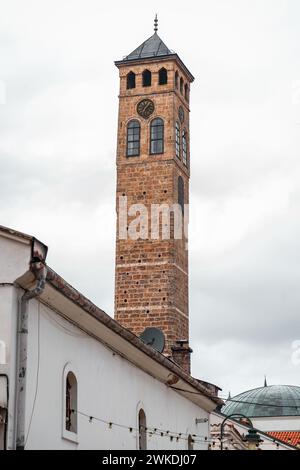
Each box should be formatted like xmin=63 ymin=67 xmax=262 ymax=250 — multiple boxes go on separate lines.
xmin=221 ymin=385 xmax=300 ymax=418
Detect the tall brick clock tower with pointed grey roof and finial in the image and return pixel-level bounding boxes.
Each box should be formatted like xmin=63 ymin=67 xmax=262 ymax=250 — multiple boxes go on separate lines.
xmin=115 ymin=18 xmax=194 ymax=372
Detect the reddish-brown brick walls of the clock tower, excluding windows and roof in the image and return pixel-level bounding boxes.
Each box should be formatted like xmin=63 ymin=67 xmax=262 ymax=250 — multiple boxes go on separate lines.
xmin=115 ymin=56 xmax=189 ymax=370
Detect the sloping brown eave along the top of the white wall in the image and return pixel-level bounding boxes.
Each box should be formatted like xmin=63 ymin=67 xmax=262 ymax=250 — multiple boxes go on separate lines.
xmin=16 ymin=266 xmax=223 ymax=411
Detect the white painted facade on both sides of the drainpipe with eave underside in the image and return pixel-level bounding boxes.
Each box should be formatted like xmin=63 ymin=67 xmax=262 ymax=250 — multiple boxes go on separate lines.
xmin=0 ymin=230 xmax=216 ymax=449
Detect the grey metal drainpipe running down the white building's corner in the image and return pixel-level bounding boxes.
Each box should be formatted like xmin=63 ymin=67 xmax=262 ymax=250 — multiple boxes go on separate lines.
xmin=16 ymin=258 xmax=47 ymax=450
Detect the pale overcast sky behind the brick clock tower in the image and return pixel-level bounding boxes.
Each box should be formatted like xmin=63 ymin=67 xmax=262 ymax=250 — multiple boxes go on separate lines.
xmin=0 ymin=0 xmax=300 ymax=396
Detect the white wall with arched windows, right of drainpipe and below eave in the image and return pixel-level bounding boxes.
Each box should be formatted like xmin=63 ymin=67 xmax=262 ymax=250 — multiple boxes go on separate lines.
xmin=26 ymin=300 xmax=208 ymax=449
